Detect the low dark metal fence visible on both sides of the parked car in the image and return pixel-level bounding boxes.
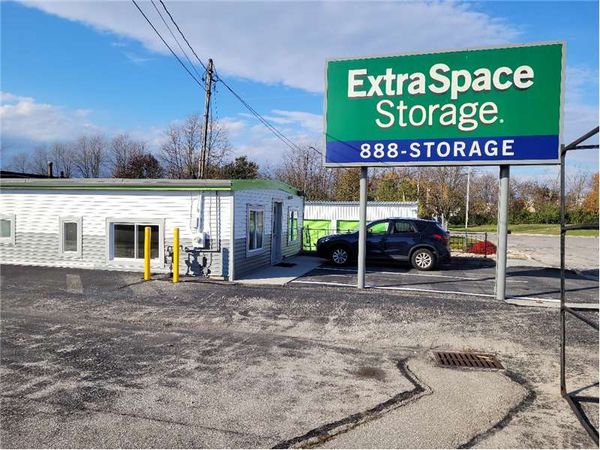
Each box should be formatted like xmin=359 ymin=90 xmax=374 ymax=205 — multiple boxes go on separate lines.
xmin=302 ymin=227 xmax=496 ymax=258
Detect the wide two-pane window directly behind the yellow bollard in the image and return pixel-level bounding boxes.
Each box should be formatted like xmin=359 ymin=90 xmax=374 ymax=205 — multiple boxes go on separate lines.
xmin=110 ymin=222 xmax=162 ymax=260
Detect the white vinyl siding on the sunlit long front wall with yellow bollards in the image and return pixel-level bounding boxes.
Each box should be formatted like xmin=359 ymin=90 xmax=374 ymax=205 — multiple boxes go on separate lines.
xmin=0 ymin=188 xmax=229 ymax=277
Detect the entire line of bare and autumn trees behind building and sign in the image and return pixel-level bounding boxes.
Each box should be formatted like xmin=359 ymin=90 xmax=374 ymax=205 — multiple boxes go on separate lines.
xmin=6 ymin=115 xmax=599 ymax=225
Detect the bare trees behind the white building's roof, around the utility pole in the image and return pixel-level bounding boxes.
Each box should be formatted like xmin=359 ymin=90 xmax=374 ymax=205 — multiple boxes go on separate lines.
xmin=7 ymin=114 xmax=259 ymax=178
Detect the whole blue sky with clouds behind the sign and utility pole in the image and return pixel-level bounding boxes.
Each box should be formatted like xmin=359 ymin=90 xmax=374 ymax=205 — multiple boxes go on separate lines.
xmin=1 ymin=1 xmax=599 ymax=177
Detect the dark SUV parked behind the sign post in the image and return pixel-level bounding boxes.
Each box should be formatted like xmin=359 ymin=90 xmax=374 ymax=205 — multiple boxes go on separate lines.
xmin=317 ymin=218 xmax=450 ymax=270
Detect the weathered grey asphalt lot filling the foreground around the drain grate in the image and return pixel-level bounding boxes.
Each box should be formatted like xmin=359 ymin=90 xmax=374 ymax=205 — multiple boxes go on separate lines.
xmin=0 ymin=266 xmax=598 ymax=448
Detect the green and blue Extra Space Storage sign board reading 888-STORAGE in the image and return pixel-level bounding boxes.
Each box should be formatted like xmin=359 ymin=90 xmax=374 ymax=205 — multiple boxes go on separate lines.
xmin=324 ymin=43 xmax=565 ymax=167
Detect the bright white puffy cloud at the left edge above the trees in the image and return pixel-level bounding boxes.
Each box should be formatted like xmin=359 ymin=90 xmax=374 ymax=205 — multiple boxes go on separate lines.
xmin=0 ymin=92 xmax=101 ymax=144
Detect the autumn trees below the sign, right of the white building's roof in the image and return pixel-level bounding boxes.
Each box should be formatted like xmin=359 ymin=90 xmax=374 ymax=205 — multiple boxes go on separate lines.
xmin=274 ymin=147 xmax=599 ymax=225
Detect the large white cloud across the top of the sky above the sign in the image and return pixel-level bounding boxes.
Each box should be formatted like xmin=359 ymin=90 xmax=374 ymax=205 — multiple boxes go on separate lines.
xmin=17 ymin=0 xmax=519 ymax=92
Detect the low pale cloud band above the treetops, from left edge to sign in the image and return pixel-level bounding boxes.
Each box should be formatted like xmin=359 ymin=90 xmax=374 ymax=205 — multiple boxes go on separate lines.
xmin=0 ymin=92 xmax=322 ymax=171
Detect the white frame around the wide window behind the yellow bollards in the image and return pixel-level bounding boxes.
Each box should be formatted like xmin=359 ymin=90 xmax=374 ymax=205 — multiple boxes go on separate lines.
xmin=106 ymin=217 xmax=165 ymax=267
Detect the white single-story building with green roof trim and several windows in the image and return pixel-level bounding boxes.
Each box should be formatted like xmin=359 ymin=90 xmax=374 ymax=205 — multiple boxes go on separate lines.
xmin=0 ymin=178 xmax=303 ymax=280
